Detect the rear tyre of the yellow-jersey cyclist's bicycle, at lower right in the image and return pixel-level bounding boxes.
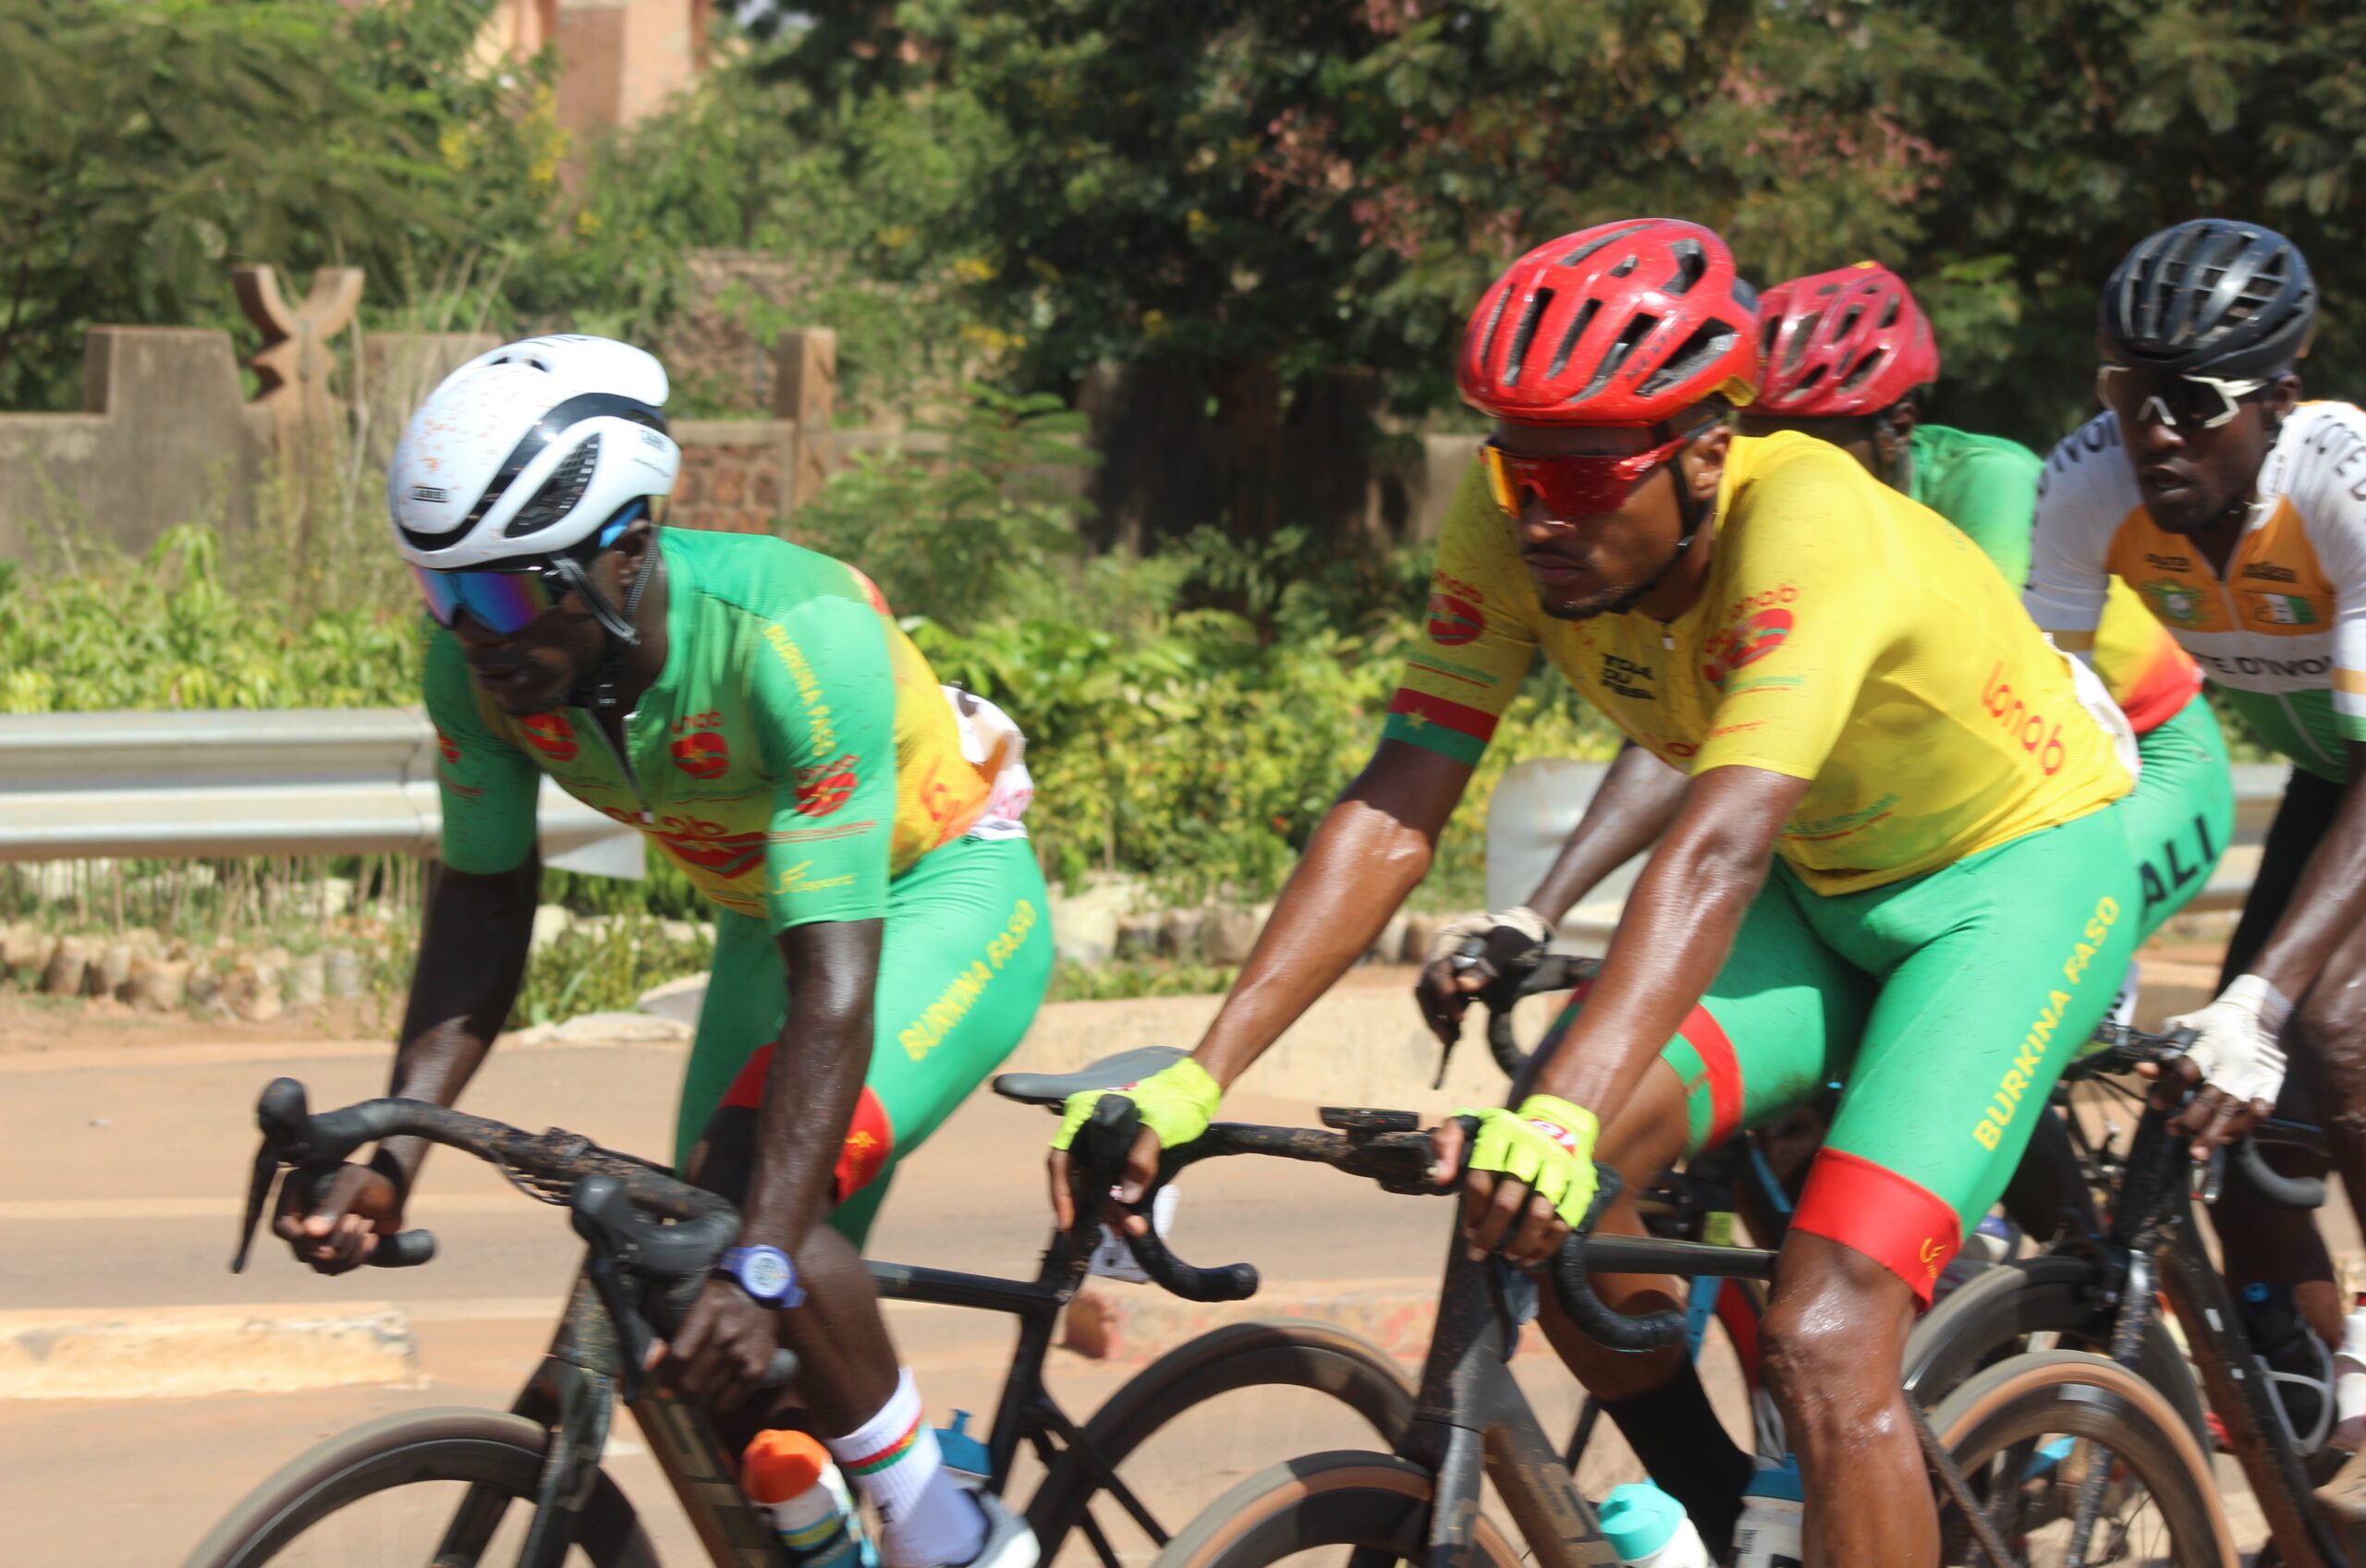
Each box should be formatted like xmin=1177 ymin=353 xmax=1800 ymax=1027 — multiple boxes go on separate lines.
xmin=1931 ymin=1351 xmax=2240 ymax=1568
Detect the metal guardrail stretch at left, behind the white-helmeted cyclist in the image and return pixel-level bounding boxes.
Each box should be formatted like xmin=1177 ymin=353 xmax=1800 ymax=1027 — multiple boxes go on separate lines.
xmin=0 ymin=707 xmax=643 ymax=878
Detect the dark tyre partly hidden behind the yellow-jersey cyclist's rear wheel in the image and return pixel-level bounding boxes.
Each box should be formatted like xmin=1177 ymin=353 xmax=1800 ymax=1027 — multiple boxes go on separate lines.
xmin=1905 ymin=1256 xmax=2210 ymax=1453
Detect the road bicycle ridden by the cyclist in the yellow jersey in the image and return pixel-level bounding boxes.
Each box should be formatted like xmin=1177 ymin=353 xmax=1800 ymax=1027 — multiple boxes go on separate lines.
xmin=1055 ymin=1098 xmax=2236 ymax=1568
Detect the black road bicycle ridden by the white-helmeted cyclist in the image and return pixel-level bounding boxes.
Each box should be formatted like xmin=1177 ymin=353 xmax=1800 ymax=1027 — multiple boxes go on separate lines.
xmin=187 ymin=1052 xmax=1412 ymax=1568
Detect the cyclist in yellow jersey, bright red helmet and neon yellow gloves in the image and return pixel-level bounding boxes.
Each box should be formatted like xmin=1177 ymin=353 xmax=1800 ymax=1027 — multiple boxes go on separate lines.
xmin=1051 ymin=220 xmax=2141 ymax=1563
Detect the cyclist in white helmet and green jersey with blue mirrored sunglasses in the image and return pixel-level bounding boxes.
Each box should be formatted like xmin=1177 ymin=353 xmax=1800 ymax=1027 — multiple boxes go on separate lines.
xmin=277 ymin=335 xmax=1051 ymax=1568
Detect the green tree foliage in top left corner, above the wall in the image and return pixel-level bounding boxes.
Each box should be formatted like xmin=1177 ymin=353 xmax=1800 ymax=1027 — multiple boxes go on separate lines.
xmin=0 ymin=0 xmax=558 ymax=409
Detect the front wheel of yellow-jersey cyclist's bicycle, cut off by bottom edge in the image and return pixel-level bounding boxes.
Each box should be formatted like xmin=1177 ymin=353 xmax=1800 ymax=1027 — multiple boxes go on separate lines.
xmin=1159 ymin=1453 xmax=1519 ymax=1568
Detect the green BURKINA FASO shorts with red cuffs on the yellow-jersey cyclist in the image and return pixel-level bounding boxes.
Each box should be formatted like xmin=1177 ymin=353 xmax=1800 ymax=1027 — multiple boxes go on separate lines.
xmin=1555 ymin=804 xmax=2141 ymax=1303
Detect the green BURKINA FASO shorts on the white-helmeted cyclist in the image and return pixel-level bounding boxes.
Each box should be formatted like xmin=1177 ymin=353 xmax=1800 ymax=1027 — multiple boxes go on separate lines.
xmin=675 ymin=837 xmax=1053 ymax=1246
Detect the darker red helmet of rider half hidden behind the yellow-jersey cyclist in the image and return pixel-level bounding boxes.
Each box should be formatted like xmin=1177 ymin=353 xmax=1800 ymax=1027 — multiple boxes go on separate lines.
xmin=1758 ymin=262 xmax=1938 ymax=419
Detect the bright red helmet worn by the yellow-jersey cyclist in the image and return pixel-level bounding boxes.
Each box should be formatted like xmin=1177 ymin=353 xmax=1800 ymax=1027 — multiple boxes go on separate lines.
xmin=1457 ymin=217 xmax=1758 ymax=426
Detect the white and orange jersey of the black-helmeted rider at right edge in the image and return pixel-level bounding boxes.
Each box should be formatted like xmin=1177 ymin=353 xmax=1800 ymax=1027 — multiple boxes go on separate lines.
xmin=2025 ymin=402 xmax=2366 ymax=781
